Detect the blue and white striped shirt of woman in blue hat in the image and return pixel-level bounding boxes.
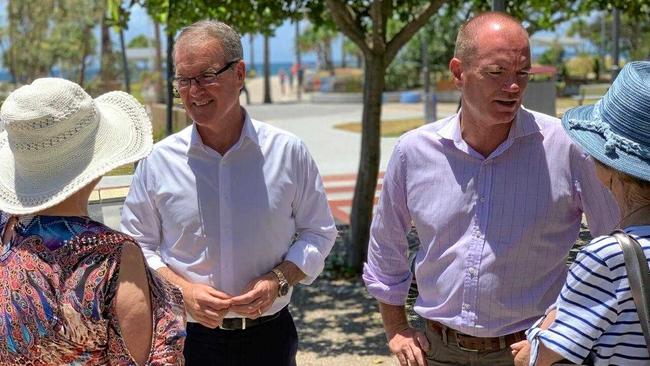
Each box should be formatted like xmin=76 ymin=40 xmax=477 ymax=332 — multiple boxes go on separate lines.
xmin=528 ymin=226 xmax=650 ymax=366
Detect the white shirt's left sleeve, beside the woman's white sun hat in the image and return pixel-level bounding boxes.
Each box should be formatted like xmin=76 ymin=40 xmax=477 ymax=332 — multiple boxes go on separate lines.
xmin=120 ymin=159 xmax=166 ymax=270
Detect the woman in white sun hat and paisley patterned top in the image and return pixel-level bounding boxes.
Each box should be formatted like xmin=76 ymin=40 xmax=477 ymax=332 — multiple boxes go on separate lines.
xmin=0 ymin=78 xmax=185 ymax=365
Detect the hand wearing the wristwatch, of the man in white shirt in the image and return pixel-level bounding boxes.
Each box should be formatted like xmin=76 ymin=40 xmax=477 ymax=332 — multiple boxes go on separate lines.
xmin=230 ymin=273 xmax=279 ymax=319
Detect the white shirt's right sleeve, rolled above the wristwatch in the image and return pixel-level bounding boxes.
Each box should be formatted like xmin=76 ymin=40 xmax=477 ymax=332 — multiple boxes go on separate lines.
xmin=285 ymin=143 xmax=337 ymax=285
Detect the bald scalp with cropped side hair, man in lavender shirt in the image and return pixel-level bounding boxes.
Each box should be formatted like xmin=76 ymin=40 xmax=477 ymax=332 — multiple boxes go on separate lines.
xmin=454 ymin=12 xmax=528 ymax=62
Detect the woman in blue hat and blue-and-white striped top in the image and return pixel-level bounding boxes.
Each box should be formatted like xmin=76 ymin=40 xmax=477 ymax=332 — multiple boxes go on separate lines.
xmin=512 ymin=62 xmax=650 ymax=366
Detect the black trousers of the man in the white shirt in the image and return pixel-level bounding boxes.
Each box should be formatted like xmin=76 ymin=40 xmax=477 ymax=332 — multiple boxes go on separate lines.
xmin=183 ymin=307 xmax=298 ymax=366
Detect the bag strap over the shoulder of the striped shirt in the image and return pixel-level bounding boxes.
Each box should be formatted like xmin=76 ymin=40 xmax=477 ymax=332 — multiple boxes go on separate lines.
xmin=612 ymin=230 xmax=650 ymax=348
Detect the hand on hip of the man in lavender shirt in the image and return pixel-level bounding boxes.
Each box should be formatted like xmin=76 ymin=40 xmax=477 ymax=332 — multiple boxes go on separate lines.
xmin=388 ymin=327 xmax=429 ymax=366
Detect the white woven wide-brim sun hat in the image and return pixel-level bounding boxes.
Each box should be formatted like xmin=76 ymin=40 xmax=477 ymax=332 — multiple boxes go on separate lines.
xmin=0 ymin=78 xmax=153 ymax=214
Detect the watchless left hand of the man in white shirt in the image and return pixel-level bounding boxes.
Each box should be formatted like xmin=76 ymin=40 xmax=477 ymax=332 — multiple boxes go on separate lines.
xmin=183 ymin=283 xmax=232 ymax=329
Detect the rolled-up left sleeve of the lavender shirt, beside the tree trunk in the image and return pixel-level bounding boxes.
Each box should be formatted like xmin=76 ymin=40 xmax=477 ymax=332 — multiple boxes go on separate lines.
xmin=363 ymin=143 xmax=412 ymax=305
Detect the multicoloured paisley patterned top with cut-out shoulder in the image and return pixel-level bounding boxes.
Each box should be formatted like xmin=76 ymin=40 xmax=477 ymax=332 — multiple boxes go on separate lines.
xmin=0 ymin=212 xmax=185 ymax=365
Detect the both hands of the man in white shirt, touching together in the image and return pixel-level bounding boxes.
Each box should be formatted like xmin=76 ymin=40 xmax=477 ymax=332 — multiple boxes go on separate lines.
xmin=183 ymin=273 xmax=279 ymax=328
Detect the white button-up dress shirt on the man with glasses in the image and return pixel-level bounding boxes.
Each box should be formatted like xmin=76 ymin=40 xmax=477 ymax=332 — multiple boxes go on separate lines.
xmin=121 ymin=114 xmax=336 ymax=320
